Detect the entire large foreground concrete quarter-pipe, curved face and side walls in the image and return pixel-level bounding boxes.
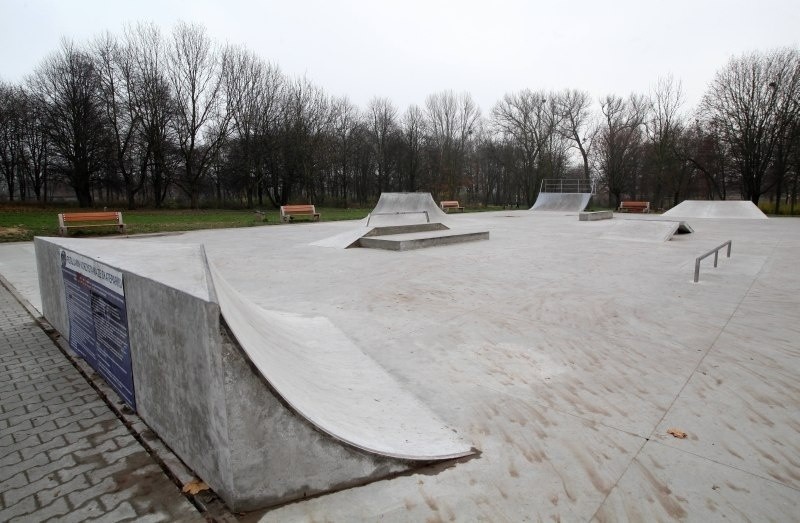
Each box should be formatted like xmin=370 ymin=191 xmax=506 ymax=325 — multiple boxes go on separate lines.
xmin=35 ymin=238 xmax=473 ymax=511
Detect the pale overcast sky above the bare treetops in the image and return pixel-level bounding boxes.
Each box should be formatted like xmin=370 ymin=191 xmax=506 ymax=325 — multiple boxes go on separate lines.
xmin=0 ymin=0 xmax=800 ymax=114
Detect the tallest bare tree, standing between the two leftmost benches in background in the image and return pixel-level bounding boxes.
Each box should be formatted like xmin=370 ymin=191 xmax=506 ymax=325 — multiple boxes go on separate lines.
xmin=168 ymin=22 xmax=230 ymax=208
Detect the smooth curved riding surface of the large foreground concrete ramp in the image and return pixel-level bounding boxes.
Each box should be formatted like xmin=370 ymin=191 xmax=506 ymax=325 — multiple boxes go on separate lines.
xmin=209 ymin=263 xmax=472 ymax=461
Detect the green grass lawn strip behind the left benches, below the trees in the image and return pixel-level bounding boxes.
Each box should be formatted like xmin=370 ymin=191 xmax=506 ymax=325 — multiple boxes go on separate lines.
xmin=0 ymin=204 xmax=370 ymax=242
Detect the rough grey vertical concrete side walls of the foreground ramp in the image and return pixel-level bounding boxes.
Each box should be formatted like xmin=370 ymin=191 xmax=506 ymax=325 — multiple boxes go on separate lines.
xmin=35 ymin=238 xmax=420 ymax=511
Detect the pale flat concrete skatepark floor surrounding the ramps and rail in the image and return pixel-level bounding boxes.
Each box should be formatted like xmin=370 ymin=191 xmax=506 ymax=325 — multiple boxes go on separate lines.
xmin=0 ymin=211 xmax=800 ymax=521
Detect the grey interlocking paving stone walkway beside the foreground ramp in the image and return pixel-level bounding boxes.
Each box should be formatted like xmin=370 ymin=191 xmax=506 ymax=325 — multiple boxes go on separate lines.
xmin=0 ymin=284 xmax=204 ymax=522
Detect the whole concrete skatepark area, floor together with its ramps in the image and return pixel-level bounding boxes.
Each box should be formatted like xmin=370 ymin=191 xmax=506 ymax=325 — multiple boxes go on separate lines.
xmin=0 ymin=194 xmax=800 ymax=521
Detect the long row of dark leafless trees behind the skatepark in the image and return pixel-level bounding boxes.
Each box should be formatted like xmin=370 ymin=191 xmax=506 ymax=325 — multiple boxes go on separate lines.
xmin=0 ymin=23 xmax=800 ymax=210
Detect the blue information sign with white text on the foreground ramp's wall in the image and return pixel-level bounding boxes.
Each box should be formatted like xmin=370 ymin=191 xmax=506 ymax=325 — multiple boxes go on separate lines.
xmin=60 ymin=249 xmax=136 ymax=410
